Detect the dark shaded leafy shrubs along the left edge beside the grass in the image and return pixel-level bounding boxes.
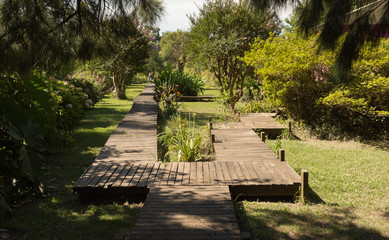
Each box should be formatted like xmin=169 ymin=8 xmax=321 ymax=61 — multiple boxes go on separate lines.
xmin=0 ymin=74 xmax=104 ymax=216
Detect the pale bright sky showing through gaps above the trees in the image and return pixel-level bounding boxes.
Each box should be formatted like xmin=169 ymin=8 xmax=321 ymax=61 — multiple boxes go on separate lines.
xmin=159 ymin=0 xmax=291 ymax=33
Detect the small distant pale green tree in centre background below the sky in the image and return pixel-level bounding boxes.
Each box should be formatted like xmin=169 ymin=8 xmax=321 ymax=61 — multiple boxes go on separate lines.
xmin=160 ymin=30 xmax=188 ymax=72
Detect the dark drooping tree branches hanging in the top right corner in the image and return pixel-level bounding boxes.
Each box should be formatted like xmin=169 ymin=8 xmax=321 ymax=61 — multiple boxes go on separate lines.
xmin=250 ymin=0 xmax=389 ymax=82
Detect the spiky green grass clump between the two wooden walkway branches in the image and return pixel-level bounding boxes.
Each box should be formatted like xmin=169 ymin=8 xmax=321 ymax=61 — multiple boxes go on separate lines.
xmin=158 ymin=113 xmax=203 ymax=162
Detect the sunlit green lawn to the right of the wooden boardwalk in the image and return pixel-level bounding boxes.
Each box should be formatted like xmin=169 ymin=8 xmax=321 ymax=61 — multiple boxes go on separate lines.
xmin=238 ymin=140 xmax=389 ymax=239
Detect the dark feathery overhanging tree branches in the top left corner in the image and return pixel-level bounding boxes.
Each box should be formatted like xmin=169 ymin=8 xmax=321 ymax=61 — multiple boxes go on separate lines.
xmin=0 ymin=0 xmax=164 ymax=73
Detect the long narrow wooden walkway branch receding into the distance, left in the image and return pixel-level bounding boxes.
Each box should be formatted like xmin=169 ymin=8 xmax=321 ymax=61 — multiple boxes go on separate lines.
xmin=95 ymin=84 xmax=158 ymax=164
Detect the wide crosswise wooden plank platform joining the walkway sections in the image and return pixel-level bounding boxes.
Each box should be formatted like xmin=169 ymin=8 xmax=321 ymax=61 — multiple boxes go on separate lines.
xmin=74 ymin=160 xmax=300 ymax=192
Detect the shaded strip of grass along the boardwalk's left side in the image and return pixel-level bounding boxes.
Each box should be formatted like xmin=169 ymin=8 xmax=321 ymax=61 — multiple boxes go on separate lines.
xmin=0 ymin=84 xmax=144 ymax=240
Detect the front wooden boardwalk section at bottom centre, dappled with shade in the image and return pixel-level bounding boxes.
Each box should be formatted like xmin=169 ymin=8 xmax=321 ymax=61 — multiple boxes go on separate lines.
xmin=128 ymin=186 xmax=240 ymax=239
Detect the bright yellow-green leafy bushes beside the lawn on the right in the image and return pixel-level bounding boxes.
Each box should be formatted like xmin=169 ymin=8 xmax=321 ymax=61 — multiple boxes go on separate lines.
xmin=244 ymin=33 xmax=389 ymax=138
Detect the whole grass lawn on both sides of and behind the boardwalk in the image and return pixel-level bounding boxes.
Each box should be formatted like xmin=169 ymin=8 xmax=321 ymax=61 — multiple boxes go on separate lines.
xmin=0 ymin=85 xmax=389 ymax=239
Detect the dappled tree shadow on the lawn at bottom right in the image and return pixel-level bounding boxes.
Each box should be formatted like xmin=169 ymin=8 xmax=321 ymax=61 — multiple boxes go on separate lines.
xmin=236 ymin=203 xmax=387 ymax=239
